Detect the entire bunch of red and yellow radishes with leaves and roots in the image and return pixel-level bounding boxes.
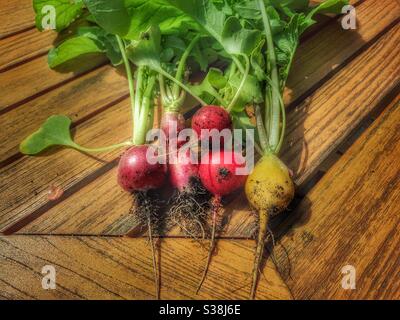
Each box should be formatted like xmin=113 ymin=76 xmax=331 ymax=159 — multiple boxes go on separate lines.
xmin=25 ymin=0 xmax=348 ymax=298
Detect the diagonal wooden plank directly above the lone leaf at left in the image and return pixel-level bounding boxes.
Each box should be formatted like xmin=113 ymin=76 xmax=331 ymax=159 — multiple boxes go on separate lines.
xmin=0 ymin=65 xmax=128 ymax=164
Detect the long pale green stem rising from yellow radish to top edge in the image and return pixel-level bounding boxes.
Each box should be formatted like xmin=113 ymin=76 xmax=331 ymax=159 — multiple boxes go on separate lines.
xmin=258 ymin=0 xmax=281 ymax=150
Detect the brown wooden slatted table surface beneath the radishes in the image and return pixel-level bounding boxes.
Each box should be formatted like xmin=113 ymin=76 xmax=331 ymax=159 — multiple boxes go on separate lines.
xmin=0 ymin=0 xmax=400 ymax=299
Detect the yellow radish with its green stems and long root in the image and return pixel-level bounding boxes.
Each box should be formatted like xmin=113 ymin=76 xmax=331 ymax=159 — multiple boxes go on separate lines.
xmin=245 ymin=0 xmax=295 ymax=299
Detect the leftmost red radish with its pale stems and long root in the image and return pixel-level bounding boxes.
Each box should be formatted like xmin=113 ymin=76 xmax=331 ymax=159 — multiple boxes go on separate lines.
xmin=117 ymin=33 xmax=167 ymax=299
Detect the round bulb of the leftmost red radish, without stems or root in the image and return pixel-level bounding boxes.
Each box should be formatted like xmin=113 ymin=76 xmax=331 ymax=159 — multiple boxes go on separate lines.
xmin=118 ymin=145 xmax=167 ymax=192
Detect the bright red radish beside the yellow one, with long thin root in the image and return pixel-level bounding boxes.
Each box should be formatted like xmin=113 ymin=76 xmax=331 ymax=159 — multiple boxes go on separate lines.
xmin=197 ymin=150 xmax=247 ymax=292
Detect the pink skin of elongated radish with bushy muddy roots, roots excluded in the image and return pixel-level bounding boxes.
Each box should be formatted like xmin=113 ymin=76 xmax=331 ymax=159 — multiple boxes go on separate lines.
xmin=169 ymin=149 xmax=199 ymax=192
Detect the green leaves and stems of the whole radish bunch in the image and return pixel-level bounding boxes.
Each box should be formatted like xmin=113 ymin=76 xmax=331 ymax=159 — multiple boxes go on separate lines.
xmin=25 ymin=0 xmax=347 ymax=154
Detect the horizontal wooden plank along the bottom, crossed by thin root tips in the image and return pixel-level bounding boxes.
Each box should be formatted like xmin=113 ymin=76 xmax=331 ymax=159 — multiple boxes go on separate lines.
xmin=0 ymin=236 xmax=290 ymax=300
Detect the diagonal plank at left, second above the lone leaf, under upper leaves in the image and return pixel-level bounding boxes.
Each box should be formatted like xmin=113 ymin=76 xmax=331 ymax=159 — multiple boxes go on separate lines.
xmin=0 ymin=52 xmax=105 ymax=113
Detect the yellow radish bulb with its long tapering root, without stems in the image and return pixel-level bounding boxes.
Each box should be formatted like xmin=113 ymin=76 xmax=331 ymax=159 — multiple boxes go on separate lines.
xmin=245 ymin=154 xmax=294 ymax=299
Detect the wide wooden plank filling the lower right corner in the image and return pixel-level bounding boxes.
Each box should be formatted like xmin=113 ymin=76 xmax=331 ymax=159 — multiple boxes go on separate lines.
xmin=281 ymin=95 xmax=400 ymax=299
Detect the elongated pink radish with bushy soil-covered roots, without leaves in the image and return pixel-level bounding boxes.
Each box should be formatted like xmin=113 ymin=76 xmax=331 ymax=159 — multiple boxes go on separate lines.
xmin=168 ymin=148 xmax=210 ymax=238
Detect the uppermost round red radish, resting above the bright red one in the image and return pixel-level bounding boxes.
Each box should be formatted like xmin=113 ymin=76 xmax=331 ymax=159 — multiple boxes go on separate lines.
xmin=192 ymin=106 xmax=232 ymax=139
